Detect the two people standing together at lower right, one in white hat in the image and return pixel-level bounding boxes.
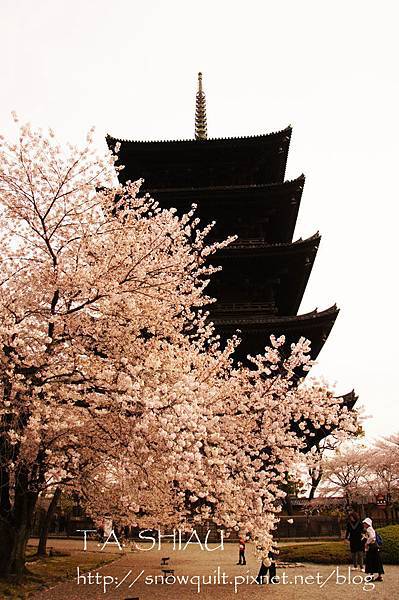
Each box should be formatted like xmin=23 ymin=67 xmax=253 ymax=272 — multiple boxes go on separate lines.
xmin=345 ymin=511 xmax=384 ymax=581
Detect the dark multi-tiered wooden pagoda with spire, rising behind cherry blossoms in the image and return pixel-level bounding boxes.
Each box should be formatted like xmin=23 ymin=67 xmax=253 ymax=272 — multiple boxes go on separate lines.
xmin=107 ymin=75 xmax=338 ymax=360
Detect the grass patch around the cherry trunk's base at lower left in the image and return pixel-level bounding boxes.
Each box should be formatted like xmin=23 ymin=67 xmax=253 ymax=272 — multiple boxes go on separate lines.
xmin=0 ymin=552 xmax=120 ymax=600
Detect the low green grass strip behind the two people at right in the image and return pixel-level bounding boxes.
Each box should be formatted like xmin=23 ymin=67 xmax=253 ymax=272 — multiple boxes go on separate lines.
xmin=278 ymin=525 xmax=399 ymax=565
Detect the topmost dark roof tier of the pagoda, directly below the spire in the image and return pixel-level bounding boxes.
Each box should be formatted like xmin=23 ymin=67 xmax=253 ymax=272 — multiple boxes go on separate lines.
xmin=106 ymin=127 xmax=292 ymax=189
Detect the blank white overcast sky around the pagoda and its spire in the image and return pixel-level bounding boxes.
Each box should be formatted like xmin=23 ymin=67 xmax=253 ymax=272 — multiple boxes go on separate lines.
xmin=0 ymin=0 xmax=399 ymax=438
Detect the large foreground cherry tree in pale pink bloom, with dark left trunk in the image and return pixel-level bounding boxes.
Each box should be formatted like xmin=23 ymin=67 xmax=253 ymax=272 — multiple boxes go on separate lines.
xmin=0 ymin=120 xmax=356 ymax=576
